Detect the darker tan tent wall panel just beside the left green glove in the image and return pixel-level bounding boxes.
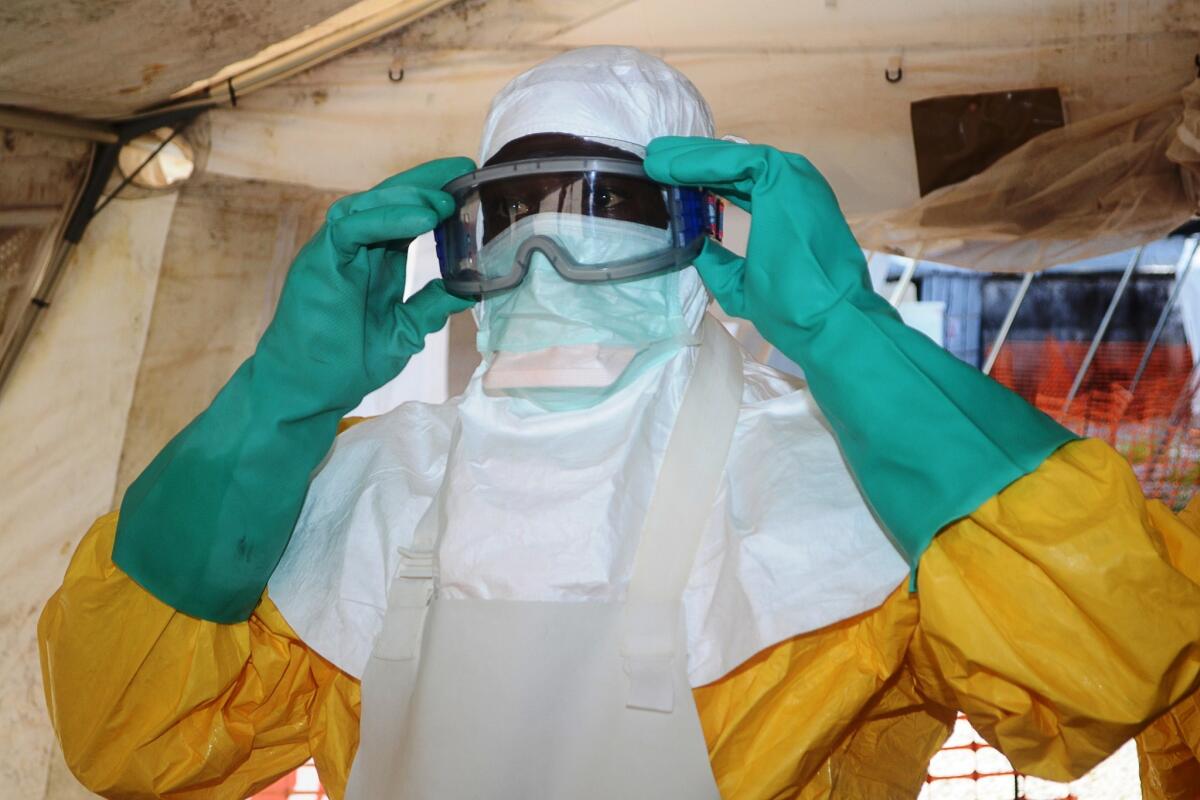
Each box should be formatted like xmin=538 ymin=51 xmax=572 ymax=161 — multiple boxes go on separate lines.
xmin=109 ymin=175 xmax=334 ymax=507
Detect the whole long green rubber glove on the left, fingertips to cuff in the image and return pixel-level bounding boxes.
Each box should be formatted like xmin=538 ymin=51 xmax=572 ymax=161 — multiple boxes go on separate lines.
xmin=113 ymin=158 xmax=475 ymax=622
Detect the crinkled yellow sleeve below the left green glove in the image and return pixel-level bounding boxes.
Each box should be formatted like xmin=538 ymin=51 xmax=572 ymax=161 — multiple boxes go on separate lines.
xmin=37 ymin=513 xmax=359 ymax=800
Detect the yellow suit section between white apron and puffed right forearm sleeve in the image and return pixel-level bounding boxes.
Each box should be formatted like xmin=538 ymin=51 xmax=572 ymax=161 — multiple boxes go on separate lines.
xmin=695 ymin=582 xmax=955 ymax=800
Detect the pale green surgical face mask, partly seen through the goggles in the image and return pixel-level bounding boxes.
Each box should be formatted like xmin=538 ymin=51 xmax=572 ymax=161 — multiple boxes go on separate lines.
xmin=475 ymin=213 xmax=708 ymax=409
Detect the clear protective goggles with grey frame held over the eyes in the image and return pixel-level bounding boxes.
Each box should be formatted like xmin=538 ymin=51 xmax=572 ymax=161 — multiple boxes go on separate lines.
xmin=434 ymin=157 xmax=724 ymax=299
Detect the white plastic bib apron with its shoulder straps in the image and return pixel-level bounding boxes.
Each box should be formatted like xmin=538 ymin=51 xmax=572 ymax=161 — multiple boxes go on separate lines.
xmin=347 ymin=318 xmax=742 ymax=800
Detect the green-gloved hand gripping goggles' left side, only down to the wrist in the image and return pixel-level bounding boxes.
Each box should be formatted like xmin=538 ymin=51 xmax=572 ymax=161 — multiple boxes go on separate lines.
xmin=254 ymin=158 xmax=475 ymax=410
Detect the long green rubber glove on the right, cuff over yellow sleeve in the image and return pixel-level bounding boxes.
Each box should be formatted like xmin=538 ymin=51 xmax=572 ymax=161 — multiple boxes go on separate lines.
xmin=646 ymin=137 xmax=1074 ymax=571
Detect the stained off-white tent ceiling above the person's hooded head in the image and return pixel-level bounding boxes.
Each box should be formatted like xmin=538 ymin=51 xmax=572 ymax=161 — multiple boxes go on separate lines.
xmin=0 ymin=0 xmax=1200 ymax=213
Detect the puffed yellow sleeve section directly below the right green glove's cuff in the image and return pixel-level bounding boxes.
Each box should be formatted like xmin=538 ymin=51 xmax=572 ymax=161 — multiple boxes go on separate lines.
xmin=910 ymin=440 xmax=1200 ymax=781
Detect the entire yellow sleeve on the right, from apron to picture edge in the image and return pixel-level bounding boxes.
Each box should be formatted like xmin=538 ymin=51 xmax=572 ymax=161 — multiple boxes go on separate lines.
xmin=696 ymin=440 xmax=1200 ymax=800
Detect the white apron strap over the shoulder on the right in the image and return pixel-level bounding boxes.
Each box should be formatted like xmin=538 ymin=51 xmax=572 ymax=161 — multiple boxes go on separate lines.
xmin=620 ymin=315 xmax=743 ymax=714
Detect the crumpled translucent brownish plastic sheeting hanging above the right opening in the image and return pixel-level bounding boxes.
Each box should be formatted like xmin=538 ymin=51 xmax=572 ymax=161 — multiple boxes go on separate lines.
xmin=854 ymin=80 xmax=1200 ymax=272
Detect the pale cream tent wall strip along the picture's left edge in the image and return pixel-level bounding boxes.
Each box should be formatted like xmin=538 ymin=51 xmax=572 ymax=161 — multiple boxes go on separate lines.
xmin=0 ymin=194 xmax=175 ymax=798
